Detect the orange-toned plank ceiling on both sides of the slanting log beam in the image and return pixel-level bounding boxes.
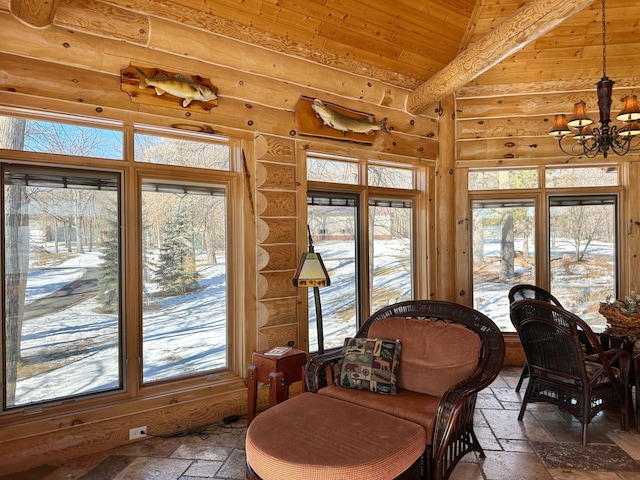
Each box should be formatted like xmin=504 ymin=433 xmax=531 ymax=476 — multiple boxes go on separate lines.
xmin=10 ymin=0 xmax=640 ymax=101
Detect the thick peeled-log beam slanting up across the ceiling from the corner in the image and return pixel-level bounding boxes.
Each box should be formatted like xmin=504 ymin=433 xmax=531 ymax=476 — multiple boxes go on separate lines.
xmin=406 ymin=0 xmax=594 ymax=114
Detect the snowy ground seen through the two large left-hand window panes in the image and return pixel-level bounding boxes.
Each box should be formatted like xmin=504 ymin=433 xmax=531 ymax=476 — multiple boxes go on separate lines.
xmin=16 ymin=253 xmax=227 ymax=405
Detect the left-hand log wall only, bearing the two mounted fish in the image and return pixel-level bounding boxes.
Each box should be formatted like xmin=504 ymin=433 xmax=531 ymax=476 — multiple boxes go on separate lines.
xmin=0 ymin=5 xmax=437 ymax=474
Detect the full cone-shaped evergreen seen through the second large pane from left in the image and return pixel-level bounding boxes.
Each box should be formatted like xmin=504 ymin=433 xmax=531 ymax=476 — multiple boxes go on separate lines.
xmin=155 ymin=205 xmax=200 ymax=296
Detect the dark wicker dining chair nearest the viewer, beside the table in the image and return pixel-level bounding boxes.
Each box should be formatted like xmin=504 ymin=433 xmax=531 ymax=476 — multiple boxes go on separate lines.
xmin=511 ymin=300 xmax=631 ymax=445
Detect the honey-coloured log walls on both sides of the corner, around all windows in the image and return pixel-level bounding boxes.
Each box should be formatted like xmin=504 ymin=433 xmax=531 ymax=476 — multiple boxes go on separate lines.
xmin=0 ymin=0 xmax=640 ymax=473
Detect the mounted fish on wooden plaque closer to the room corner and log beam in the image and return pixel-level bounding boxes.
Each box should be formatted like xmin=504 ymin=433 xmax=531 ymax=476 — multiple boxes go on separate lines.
xmin=295 ymin=96 xmax=387 ymax=145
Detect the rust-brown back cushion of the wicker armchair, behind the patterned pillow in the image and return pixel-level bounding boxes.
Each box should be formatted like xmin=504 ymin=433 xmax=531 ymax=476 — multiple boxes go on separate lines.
xmin=368 ymin=317 xmax=481 ymax=397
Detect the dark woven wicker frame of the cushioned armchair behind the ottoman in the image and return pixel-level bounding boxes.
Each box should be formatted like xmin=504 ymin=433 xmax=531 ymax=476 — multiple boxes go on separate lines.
xmin=305 ymin=300 xmax=505 ymax=480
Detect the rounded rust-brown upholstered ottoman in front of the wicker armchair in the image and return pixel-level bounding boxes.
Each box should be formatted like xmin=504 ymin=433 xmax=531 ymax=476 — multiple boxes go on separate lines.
xmin=246 ymin=392 xmax=426 ymax=480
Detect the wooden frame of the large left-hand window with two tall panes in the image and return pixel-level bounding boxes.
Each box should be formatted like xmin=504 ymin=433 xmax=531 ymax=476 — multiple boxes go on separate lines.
xmin=0 ymin=108 xmax=248 ymax=428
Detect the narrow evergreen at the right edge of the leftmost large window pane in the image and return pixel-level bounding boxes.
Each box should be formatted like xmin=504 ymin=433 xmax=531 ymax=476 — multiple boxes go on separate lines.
xmin=98 ymin=203 xmax=120 ymax=313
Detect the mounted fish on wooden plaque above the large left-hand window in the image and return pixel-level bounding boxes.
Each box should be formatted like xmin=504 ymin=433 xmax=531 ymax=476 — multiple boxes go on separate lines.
xmin=120 ymin=65 xmax=218 ymax=112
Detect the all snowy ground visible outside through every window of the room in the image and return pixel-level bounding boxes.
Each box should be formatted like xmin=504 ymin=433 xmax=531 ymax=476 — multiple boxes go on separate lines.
xmin=16 ymin=235 xmax=612 ymax=405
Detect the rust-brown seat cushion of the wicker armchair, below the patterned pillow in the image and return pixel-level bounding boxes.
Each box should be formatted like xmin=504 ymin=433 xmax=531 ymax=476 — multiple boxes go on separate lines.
xmin=318 ymin=385 xmax=440 ymax=445
